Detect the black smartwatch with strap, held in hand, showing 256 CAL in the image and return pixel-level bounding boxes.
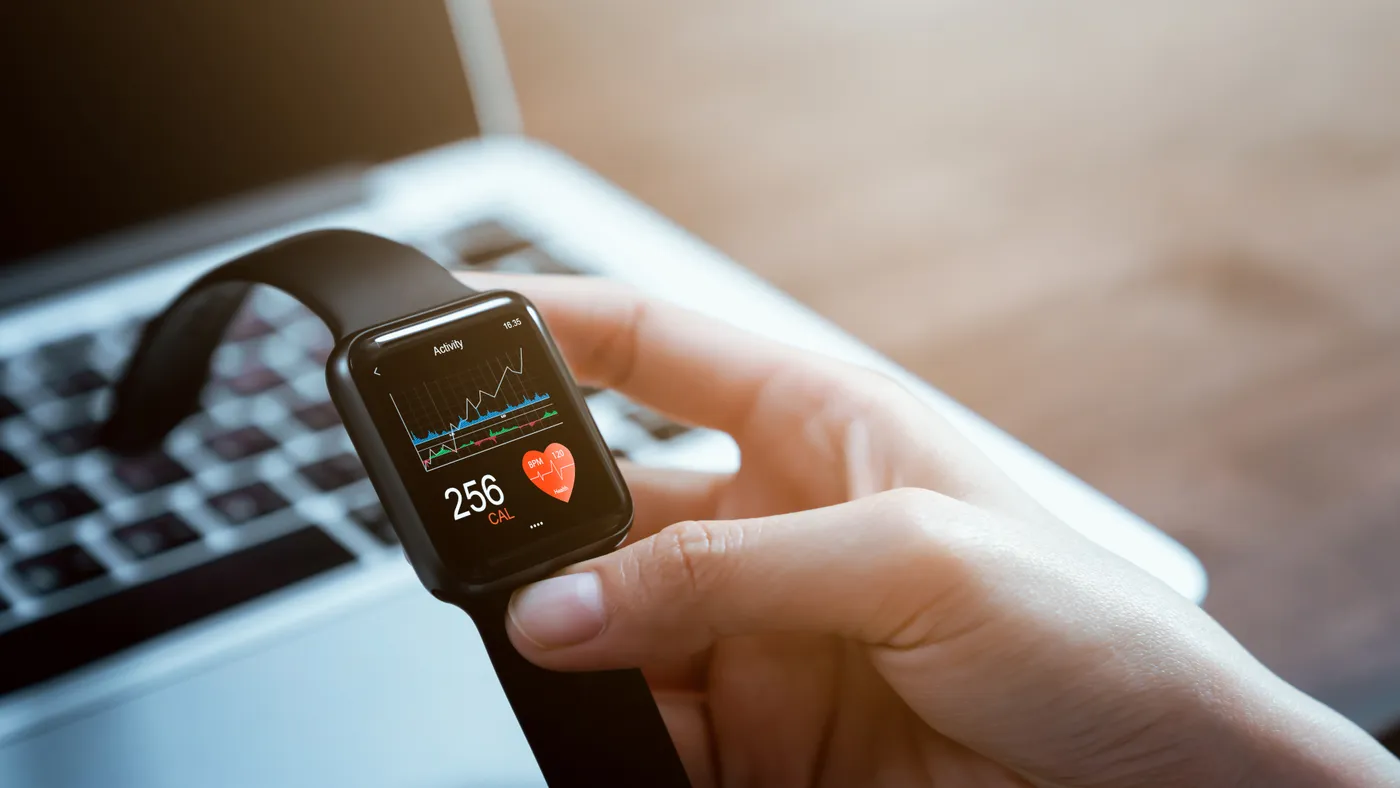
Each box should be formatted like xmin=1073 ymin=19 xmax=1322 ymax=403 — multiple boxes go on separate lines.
xmin=102 ymin=230 xmax=689 ymax=788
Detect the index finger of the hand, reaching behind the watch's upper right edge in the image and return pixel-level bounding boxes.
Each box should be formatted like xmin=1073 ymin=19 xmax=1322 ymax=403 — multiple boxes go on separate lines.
xmin=461 ymin=274 xmax=808 ymax=434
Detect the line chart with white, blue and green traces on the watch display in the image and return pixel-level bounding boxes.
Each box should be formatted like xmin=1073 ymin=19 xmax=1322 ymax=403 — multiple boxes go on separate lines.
xmin=389 ymin=349 xmax=561 ymax=472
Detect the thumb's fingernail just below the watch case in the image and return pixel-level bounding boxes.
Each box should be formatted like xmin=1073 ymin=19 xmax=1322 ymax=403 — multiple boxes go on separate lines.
xmin=510 ymin=572 xmax=605 ymax=648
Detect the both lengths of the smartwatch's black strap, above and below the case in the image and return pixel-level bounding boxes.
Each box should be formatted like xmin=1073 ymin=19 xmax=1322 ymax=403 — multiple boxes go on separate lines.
xmin=102 ymin=230 xmax=689 ymax=788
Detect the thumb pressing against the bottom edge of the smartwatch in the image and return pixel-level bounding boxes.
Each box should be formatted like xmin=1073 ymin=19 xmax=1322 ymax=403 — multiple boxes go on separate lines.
xmin=508 ymin=490 xmax=977 ymax=669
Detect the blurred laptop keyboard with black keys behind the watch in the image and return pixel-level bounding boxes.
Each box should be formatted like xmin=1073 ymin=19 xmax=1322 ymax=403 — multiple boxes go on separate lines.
xmin=0 ymin=223 xmax=690 ymax=696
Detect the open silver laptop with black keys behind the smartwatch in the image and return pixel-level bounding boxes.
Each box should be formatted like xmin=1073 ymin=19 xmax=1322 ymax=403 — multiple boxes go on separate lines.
xmin=0 ymin=0 xmax=1205 ymax=788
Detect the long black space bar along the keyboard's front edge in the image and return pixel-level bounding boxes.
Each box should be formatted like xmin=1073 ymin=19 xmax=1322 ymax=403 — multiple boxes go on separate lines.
xmin=0 ymin=526 xmax=354 ymax=694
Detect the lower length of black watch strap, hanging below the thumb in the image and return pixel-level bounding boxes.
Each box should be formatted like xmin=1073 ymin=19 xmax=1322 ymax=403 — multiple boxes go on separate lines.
xmin=462 ymin=592 xmax=690 ymax=788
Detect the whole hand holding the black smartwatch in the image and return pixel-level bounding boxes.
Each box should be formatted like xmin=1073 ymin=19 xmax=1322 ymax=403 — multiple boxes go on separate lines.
xmin=469 ymin=277 xmax=1400 ymax=787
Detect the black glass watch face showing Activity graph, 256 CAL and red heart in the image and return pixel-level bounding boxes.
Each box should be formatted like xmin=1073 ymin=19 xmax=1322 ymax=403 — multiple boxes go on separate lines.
xmin=349 ymin=293 xmax=631 ymax=584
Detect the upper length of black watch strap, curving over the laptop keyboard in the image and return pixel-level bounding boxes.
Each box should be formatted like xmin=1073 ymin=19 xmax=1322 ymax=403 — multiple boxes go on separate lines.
xmin=102 ymin=230 xmax=473 ymax=453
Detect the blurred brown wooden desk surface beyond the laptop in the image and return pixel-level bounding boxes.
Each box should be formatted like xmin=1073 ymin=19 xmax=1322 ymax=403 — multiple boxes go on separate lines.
xmin=497 ymin=0 xmax=1400 ymax=725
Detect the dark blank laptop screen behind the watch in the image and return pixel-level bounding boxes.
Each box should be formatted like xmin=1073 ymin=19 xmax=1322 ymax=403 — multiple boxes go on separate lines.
xmin=0 ymin=0 xmax=477 ymax=269
